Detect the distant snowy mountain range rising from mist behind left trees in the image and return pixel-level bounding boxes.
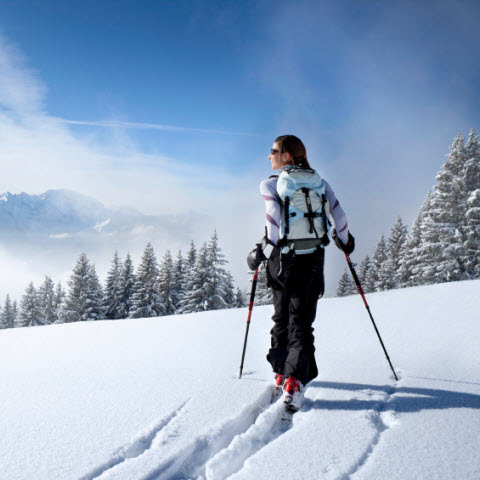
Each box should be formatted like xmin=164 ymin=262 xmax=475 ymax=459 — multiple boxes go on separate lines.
xmin=0 ymin=190 xmax=215 ymax=302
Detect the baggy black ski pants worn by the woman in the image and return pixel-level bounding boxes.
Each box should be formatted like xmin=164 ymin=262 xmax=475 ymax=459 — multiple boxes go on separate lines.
xmin=267 ymin=247 xmax=324 ymax=385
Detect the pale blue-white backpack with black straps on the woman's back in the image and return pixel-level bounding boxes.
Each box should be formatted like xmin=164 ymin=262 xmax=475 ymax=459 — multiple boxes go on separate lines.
xmin=277 ymin=166 xmax=331 ymax=253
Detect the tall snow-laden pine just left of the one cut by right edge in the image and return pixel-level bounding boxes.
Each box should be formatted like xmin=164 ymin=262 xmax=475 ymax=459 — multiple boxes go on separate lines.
xmin=419 ymin=133 xmax=468 ymax=284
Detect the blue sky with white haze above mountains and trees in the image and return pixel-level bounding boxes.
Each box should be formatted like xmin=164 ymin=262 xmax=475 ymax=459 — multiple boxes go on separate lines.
xmin=0 ymin=0 xmax=480 ymax=292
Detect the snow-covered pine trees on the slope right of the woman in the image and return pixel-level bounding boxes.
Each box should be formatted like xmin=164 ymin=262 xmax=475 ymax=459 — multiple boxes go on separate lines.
xmin=337 ymin=129 xmax=480 ymax=296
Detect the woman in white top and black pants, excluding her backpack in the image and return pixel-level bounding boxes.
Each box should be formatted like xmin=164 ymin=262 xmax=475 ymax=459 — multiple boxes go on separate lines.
xmin=247 ymin=135 xmax=355 ymax=411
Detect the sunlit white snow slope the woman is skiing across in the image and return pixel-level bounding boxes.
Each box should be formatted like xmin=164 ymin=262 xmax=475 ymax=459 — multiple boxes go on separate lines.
xmin=0 ymin=281 xmax=480 ymax=480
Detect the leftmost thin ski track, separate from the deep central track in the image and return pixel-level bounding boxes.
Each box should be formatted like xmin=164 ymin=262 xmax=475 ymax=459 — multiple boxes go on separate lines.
xmin=80 ymin=400 xmax=189 ymax=480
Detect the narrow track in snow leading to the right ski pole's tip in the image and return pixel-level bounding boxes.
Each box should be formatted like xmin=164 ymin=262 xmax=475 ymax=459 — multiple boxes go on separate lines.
xmin=337 ymin=373 xmax=402 ymax=480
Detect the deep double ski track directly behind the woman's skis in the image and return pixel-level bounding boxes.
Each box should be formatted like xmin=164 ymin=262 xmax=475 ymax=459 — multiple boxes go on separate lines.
xmin=135 ymin=386 xmax=290 ymax=480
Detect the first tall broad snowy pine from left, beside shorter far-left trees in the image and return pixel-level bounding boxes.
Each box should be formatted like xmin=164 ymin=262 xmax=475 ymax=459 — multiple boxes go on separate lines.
xmin=61 ymin=253 xmax=104 ymax=322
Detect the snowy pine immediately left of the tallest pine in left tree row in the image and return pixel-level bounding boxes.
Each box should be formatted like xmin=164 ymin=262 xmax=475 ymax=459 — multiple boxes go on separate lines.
xmin=179 ymin=242 xmax=211 ymax=314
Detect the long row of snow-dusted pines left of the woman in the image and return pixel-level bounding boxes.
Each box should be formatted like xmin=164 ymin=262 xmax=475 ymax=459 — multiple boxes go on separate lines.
xmin=0 ymin=232 xmax=245 ymax=328
